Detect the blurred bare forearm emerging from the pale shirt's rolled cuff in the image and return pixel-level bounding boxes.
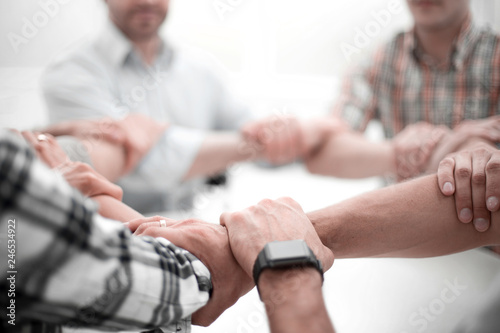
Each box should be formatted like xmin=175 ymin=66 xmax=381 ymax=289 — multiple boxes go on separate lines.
xmin=184 ymin=133 xmax=258 ymax=180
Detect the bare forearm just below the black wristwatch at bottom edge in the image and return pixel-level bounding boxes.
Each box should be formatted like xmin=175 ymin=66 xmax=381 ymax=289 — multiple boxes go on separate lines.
xmin=259 ymin=268 xmax=334 ymax=333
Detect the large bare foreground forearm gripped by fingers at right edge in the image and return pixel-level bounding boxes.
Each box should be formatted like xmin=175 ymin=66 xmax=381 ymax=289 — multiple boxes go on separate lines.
xmin=308 ymin=175 xmax=500 ymax=258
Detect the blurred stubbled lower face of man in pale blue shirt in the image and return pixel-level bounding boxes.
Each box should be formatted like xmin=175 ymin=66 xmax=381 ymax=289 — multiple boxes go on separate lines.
xmin=106 ymin=0 xmax=170 ymax=41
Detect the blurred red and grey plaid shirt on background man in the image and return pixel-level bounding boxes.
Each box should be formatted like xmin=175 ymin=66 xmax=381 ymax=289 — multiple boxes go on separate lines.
xmin=334 ymin=17 xmax=500 ymax=138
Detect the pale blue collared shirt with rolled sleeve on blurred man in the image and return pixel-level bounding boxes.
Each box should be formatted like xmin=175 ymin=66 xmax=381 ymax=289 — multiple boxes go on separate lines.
xmin=42 ymin=23 xmax=252 ymax=211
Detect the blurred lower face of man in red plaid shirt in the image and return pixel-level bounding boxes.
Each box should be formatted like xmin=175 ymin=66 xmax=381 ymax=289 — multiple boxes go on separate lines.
xmin=407 ymin=0 xmax=470 ymax=29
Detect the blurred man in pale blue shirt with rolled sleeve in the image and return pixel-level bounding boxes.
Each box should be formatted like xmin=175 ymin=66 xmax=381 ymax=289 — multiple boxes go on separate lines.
xmin=42 ymin=0 xmax=326 ymax=212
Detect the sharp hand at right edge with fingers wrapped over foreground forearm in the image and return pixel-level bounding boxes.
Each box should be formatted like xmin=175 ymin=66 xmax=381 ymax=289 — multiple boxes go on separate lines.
xmin=438 ymin=144 xmax=500 ymax=232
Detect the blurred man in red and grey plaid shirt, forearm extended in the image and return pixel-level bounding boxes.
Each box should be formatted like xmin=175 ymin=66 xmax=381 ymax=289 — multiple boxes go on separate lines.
xmin=246 ymin=0 xmax=500 ymax=223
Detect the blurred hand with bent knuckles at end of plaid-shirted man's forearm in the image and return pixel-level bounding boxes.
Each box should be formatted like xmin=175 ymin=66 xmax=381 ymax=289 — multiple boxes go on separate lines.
xmin=392 ymin=122 xmax=450 ymax=181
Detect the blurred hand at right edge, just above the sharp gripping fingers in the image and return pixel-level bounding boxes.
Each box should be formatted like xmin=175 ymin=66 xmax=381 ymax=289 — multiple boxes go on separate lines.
xmin=427 ymin=116 xmax=500 ymax=172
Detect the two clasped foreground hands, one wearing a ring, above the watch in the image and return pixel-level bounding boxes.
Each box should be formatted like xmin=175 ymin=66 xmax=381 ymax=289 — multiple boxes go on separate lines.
xmin=127 ymin=198 xmax=333 ymax=326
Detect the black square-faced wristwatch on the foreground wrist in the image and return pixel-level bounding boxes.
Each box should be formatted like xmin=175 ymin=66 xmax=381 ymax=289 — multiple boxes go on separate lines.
xmin=253 ymin=239 xmax=323 ymax=289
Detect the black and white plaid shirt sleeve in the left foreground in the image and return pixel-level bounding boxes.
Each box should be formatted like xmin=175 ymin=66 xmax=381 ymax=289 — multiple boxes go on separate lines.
xmin=0 ymin=130 xmax=212 ymax=332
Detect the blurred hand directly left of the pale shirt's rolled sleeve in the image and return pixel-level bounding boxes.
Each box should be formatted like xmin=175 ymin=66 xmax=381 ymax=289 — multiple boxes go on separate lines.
xmin=119 ymin=113 xmax=168 ymax=174
